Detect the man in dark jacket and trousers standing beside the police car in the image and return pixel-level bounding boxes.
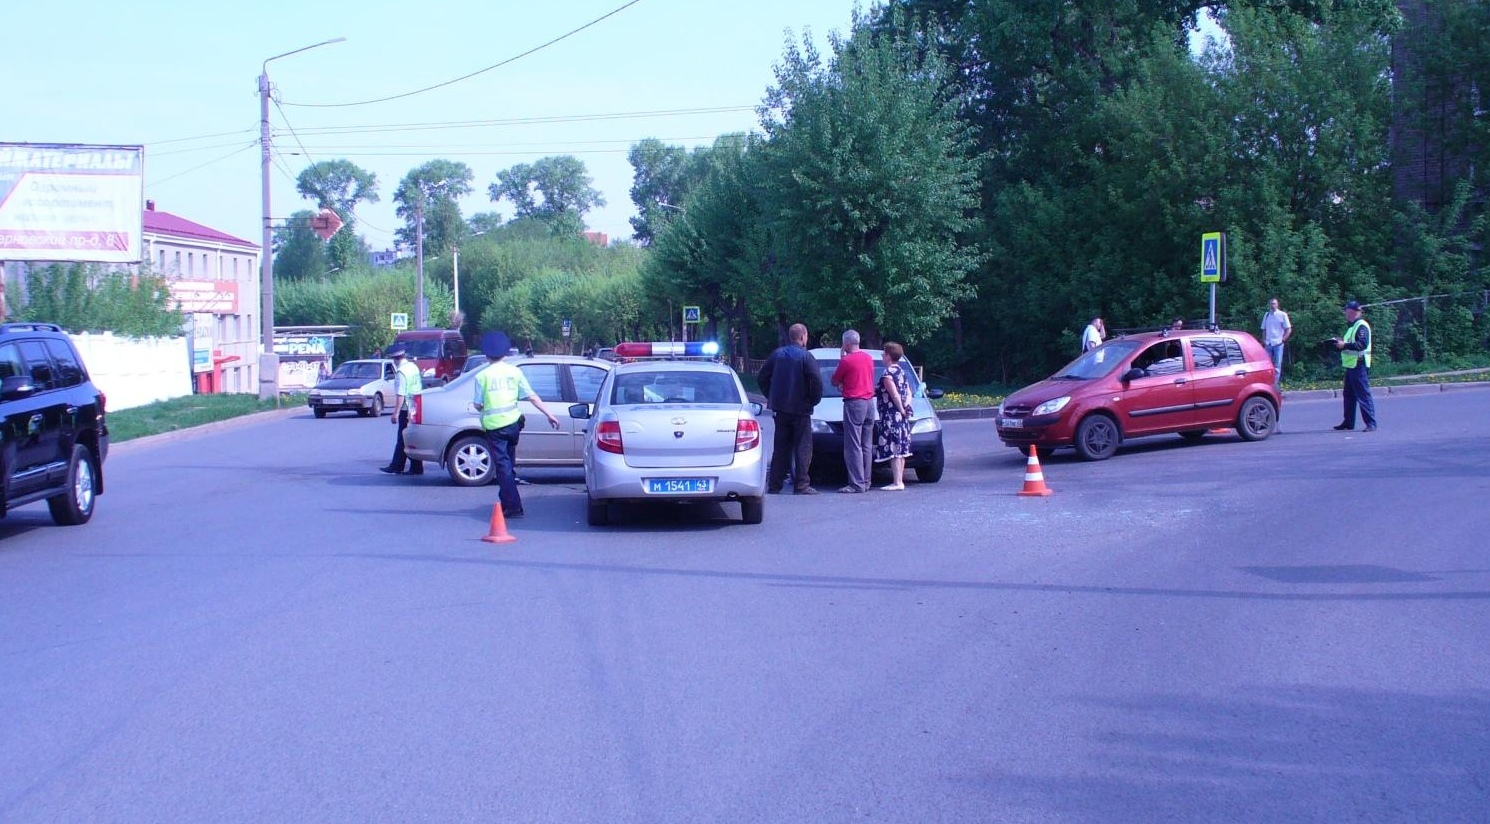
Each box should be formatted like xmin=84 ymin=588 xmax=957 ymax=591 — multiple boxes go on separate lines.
xmin=755 ymin=323 xmax=822 ymax=495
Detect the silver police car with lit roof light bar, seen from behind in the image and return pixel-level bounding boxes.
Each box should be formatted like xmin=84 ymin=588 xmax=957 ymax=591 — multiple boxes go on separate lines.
xmin=569 ymin=341 xmax=766 ymax=526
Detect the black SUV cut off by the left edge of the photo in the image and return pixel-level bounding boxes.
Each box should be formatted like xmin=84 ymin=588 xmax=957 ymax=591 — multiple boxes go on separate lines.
xmin=0 ymin=323 xmax=109 ymax=526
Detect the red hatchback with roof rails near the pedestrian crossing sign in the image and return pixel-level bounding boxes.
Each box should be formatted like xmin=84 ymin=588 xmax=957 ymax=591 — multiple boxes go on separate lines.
xmin=997 ymin=329 xmax=1283 ymax=460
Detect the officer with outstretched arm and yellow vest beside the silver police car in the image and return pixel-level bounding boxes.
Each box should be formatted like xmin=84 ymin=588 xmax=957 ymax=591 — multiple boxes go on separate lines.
xmin=472 ymin=332 xmax=559 ymax=519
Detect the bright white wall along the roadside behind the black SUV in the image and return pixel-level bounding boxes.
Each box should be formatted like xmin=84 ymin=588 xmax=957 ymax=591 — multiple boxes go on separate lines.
xmin=69 ymin=332 xmax=192 ymax=411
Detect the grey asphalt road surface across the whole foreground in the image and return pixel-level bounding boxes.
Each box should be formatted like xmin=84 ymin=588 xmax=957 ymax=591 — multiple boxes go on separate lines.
xmin=0 ymin=389 xmax=1490 ymax=823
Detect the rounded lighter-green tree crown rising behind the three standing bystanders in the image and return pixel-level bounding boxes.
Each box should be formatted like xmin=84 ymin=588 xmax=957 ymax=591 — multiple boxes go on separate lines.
xmin=763 ymin=21 xmax=979 ymax=344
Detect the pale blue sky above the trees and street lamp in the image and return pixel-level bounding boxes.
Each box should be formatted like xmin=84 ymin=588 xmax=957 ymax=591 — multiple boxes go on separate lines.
xmin=0 ymin=0 xmax=863 ymax=249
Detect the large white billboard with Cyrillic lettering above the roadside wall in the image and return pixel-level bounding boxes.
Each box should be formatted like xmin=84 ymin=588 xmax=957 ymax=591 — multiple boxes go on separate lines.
xmin=0 ymin=143 xmax=145 ymax=264
